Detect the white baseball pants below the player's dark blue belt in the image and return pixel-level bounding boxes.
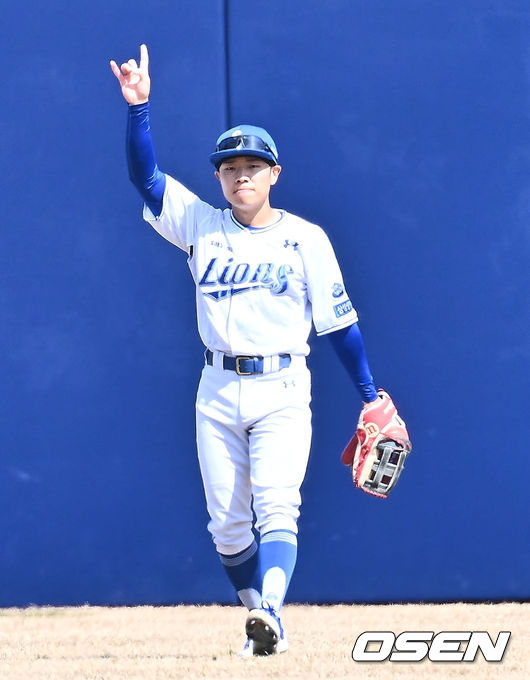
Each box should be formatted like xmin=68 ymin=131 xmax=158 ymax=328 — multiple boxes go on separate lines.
xmin=196 ymin=357 xmax=311 ymax=555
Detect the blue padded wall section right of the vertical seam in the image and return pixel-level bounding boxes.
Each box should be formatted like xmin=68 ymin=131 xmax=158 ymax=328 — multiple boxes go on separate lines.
xmin=230 ymin=0 xmax=530 ymax=601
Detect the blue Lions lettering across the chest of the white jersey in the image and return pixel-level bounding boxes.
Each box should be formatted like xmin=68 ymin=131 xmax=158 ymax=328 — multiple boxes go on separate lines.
xmin=199 ymin=257 xmax=294 ymax=300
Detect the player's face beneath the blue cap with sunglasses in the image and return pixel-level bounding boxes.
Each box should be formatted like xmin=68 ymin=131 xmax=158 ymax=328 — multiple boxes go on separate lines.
xmin=215 ymin=156 xmax=281 ymax=208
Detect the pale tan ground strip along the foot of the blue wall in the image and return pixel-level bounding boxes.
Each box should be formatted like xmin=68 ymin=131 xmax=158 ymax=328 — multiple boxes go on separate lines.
xmin=0 ymin=603 xmax=530 ymax=680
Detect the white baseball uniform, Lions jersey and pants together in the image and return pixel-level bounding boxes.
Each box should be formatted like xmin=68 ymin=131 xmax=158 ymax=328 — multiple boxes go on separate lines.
xmin=144 ymin=176 xmax=357 ymax=555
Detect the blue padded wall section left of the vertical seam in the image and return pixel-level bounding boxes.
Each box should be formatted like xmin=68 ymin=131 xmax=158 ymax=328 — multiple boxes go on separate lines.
xmin=0 ymin=0 xmax=226 ymax=605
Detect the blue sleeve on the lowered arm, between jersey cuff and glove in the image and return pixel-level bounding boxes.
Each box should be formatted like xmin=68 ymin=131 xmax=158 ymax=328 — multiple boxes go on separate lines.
xmin=329 ymin=323 xmax=377 ymax=402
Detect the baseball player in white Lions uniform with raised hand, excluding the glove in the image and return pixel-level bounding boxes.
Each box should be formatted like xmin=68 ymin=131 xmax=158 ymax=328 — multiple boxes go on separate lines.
xmin=110 ymin=45 xmax=378 ymax=656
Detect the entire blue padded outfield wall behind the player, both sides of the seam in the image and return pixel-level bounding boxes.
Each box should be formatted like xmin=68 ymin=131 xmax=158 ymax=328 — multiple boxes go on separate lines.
xmin=0 ymin=0 xmax=530 ymax=606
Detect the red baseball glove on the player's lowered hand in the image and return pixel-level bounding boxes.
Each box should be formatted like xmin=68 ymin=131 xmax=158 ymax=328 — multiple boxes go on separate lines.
xmin=341 ymin=390 xmax=412 ymax=498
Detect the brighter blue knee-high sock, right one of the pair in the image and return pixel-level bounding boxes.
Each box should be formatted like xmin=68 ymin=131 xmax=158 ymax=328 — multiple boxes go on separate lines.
xmin=259 ymin=531 xmax=298 ymax=611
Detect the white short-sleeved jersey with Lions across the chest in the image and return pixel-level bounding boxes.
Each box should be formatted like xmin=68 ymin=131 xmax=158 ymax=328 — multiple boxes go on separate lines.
xmin=144 ymin=175 xmax=357 ymax=356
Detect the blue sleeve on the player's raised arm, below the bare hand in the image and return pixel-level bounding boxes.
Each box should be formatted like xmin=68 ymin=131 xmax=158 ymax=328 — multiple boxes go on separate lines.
xmin=126 ymin=102 xmax=166 ymax=217
